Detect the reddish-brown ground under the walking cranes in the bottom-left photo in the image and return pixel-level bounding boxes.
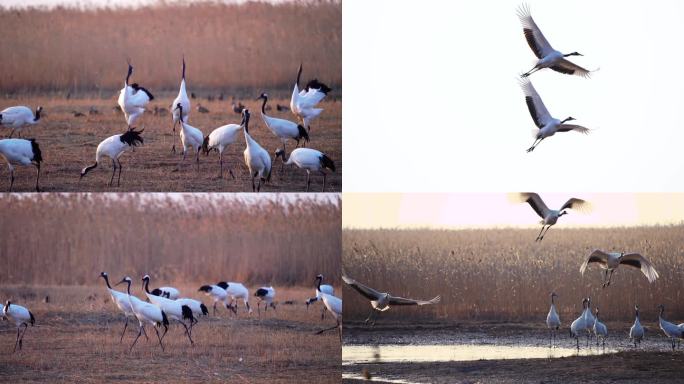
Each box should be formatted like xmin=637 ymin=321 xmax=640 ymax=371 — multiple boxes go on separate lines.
xmin=0 ymin=283 xmax=341 ymax=383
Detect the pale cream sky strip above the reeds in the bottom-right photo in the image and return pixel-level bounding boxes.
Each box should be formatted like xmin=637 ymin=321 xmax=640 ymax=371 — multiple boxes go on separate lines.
xmin=342 ymin=193 xmax=684 ymax=228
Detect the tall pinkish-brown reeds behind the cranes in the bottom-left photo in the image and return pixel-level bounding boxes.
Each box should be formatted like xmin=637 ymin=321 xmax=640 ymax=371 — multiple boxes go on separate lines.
xmin=0 ymin=194 xmax=341 ymax=286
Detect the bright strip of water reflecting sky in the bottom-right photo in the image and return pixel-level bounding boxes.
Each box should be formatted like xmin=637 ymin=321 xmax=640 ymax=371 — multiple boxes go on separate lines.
xmin=342 ymin=344 xmax=616 ymax=365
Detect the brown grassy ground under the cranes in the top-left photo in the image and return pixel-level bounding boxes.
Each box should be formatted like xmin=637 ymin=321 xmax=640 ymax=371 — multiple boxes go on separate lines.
xmin=0 ymin=92 xmax=342 ymax=192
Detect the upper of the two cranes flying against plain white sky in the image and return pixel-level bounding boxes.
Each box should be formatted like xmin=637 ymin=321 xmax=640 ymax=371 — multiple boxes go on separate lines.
xmin=518 ymin=6 xmax=592 ymax=77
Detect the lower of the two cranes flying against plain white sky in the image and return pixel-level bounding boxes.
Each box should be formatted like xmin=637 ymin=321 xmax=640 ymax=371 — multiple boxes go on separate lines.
xmin=520 ymin=79 xmax=590 ymax=152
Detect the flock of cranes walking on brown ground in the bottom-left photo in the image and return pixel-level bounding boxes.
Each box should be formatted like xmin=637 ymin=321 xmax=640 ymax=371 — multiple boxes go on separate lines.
xmin=3 ymin=272 xmax=342 ymax=352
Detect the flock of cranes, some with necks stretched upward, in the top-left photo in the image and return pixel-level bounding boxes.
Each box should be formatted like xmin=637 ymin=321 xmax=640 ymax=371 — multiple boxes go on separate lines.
xmin=0 ymin=58 xmax=335 ymax=192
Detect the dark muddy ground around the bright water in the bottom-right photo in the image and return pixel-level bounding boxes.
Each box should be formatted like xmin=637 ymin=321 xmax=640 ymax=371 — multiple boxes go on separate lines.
xmin=342 ymin=321 xmax=684 ymax=383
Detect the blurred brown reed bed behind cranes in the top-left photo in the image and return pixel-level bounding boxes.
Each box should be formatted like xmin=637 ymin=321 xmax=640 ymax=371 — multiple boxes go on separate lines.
xmin=0 ymin=1 xmax=342 ymax=94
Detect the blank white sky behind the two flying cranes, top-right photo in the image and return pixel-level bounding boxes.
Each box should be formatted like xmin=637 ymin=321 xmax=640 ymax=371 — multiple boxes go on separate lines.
xmin=342 ymin=0 xmax=684 ymax=192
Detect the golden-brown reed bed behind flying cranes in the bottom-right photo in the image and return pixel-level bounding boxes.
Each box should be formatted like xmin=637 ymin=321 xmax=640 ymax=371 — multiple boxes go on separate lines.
xmin=342 ymin=225 xmax=684 ymax=327
